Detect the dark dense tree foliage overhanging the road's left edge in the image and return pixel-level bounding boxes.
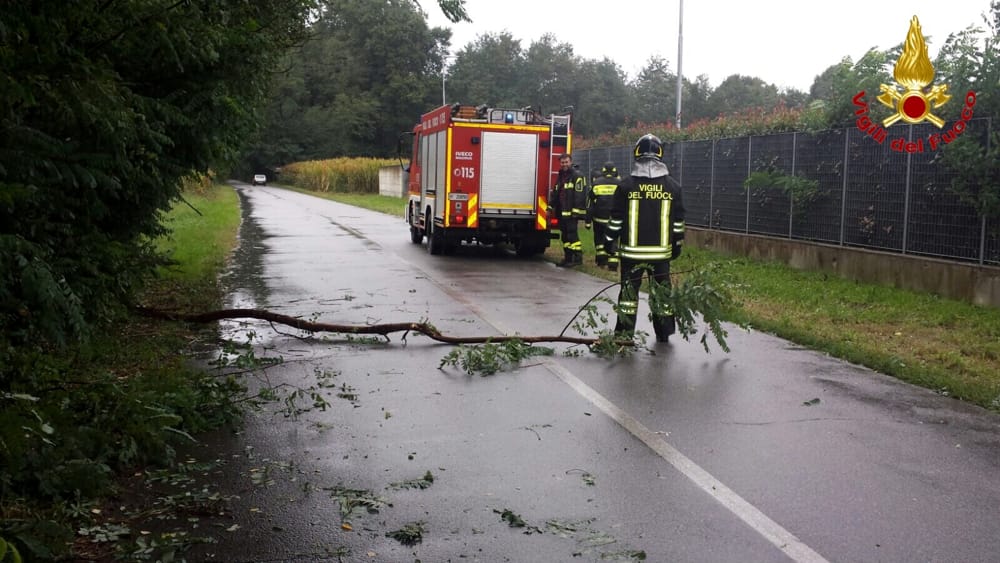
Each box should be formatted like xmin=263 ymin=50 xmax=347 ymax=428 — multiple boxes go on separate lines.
xmin=0 ymin=0 xmax=312 ymax=352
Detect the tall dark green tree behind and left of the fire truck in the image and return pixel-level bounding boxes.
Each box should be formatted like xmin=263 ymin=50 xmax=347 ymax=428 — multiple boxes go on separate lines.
xmin=247 ymin=0 xmax=450 ymax=166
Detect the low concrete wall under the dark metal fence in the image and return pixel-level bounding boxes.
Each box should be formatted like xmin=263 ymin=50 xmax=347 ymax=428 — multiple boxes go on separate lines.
xmin=685 ymin=226 xmax=1000 ymax=307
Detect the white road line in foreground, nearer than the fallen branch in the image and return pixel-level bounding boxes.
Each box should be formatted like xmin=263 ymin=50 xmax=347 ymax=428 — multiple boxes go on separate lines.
xmin=544 ymin=360 xmax=827 ymax=563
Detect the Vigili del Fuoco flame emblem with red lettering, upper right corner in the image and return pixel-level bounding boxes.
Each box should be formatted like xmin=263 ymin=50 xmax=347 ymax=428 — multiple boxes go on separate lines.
xmin=853 ymin=16 xmax=976 ymax=153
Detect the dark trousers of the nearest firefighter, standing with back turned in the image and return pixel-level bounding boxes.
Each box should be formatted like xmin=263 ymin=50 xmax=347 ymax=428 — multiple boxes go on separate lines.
xmin=615 ymin=258 xmax=676 ymax=342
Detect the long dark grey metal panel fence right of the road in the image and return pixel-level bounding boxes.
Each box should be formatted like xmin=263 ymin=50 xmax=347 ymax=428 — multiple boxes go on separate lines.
xmin=574 ymin=118 xmax=1000 ymax=265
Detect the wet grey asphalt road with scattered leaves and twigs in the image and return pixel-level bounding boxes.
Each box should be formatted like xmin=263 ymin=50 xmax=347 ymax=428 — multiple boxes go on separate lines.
xmin=189 ymin=184 xmax=1000 ymax=562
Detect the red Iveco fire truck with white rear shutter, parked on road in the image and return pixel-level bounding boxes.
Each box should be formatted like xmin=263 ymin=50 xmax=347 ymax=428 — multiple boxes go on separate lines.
xmin=400 ymin=104 xmax=572 ymax=256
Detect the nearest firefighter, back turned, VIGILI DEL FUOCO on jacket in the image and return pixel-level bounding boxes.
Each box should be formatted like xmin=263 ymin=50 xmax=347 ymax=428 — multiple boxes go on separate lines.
xmin=605 ymin=135 xmax=684 ymax=342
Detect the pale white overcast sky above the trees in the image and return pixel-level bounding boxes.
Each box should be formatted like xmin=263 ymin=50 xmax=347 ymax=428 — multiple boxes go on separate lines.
xmin=421 ymin=0 xmax=989 ymax=92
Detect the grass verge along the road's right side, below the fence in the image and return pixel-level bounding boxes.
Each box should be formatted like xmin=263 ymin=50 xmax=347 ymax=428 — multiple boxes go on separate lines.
xmin=276 ymin=187 xmax=1000 ymax=411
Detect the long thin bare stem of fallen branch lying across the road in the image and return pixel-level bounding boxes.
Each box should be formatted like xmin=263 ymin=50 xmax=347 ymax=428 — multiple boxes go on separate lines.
xmin=136 ymin=307 xmax=598 ymax=346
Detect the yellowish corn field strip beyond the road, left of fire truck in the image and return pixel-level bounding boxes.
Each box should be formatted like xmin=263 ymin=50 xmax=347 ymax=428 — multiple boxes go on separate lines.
xmin=281 ymin=158 xmax=399 ymax=194
